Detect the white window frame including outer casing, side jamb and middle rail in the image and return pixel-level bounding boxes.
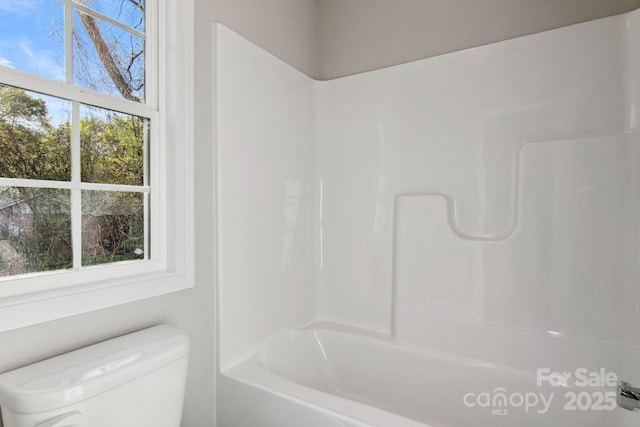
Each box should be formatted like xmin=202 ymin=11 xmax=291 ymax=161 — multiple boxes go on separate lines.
xmin=0 ymin=0 xmax=195 ymax=332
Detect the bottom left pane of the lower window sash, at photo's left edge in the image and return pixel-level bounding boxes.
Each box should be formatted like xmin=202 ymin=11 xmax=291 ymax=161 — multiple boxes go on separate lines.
xmin=0 ymin=187 xmax=72 ymax=276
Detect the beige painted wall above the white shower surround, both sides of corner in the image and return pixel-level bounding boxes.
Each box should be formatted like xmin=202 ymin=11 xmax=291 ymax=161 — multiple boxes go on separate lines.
xmin=198 ymin=0 xmax=640 ymax=80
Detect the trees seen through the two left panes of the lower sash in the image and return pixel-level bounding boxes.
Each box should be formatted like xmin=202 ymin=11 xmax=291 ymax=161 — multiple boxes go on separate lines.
xmin=0 ymin=86 xmax=71 ymax=274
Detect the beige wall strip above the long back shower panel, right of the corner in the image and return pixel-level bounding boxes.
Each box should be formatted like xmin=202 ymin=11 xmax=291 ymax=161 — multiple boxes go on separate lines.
xmin=316 ymin=0 xmax=640 ymax=80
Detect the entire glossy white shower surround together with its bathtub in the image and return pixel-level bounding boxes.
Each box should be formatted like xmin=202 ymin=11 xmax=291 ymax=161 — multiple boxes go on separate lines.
xmin=215 ymin=7 xmax=640 ymax=427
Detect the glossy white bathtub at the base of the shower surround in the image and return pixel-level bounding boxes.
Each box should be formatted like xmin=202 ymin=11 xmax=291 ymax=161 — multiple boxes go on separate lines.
xmin=223 ymin=327 xmax=640 ymax=427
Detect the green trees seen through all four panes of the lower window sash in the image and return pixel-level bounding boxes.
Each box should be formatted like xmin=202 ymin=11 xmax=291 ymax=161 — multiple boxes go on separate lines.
xmin=0 ymin=85 xmax=146 ymax=275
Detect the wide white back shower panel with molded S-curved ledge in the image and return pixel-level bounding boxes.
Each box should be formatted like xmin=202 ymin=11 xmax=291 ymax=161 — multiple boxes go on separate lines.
xmin=316 ymin=12 xmax=640 ymax=342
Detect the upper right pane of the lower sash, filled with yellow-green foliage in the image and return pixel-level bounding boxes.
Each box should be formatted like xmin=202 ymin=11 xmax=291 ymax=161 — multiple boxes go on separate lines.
xmin=80 ymin=105 xmax=148 ymax=185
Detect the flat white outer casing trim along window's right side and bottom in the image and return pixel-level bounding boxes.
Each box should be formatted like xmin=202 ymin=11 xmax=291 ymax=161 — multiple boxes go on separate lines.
xmin=0 ymin=0 xmax=195 ymax=332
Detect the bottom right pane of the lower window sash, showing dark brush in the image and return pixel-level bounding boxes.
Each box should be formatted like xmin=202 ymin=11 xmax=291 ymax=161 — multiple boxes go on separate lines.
xmin=82 ymin=191 xmax=146 ymax=265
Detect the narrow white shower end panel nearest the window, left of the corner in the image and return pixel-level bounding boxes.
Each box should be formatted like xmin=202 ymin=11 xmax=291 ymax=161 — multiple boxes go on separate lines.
xmin=215 ymin=24 xmax=317 ymax=371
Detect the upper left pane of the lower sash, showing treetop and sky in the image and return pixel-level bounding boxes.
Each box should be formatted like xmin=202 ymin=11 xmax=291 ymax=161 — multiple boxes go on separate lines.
xmin=0 ymin=84 xmax=71 ymax=181
